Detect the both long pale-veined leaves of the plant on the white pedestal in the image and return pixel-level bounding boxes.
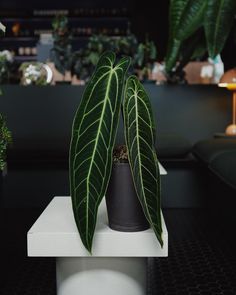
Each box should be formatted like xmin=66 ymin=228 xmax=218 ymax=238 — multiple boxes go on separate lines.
xmin=69 ymin=51 xmax=163 ymax=253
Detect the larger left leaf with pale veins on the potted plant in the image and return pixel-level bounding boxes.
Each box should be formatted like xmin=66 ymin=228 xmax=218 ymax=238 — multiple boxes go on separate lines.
xmin=70 ymin=52 xmax=130 ymax=252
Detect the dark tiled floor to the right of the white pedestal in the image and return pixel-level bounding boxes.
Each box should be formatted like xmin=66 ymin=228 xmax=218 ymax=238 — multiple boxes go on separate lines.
xmin=150 ymin=209 xmax=236 ymax=295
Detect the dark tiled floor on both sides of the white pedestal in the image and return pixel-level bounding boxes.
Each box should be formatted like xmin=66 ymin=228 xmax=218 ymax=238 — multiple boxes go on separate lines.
xmin=0 ymin=209 xmax=236 ymax=295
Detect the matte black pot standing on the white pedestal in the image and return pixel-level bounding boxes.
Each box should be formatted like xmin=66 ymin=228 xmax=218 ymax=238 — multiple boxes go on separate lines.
xmin=106 ymin=163 xmax=149 ymax=232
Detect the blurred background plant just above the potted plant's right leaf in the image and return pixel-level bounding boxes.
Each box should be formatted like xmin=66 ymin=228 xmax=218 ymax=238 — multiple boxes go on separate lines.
xmin=135 ymin=38 xmax=157 ymax=80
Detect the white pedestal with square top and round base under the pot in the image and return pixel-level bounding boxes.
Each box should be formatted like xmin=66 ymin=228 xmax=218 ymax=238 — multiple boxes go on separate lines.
xmin=27 ymin=164 xmax=168 ymax=295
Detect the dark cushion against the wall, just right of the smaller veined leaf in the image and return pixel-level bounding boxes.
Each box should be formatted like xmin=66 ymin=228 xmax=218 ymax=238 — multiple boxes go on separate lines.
xmin=156 ymin=134 xmax=192 ymax=159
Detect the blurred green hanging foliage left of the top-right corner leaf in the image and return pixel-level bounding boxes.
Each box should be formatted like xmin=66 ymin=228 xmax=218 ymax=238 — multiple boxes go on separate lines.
xmin=166 ymin=0 xmax=207 ymax=72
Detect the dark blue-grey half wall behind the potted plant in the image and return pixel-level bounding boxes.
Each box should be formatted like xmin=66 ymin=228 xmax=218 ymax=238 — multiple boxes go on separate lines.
xmin=0 ymin=84 xmax=231 ymax=149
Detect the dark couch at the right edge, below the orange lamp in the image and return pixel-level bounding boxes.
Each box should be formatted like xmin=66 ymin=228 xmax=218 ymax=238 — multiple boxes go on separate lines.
xmin=193 ymin=137 xmax=236 ymax=224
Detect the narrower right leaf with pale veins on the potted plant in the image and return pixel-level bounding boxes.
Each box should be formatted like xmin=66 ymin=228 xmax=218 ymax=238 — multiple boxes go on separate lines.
xmin=123 ymin=76 xmax=163 ymax=246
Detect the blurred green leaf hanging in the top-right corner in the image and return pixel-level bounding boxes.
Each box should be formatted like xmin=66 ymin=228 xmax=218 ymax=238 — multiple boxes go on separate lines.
xmin=204 ymin=0 xmax=236 ymax=58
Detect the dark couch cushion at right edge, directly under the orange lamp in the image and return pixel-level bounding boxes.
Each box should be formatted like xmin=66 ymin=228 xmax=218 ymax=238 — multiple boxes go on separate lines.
xmin=192 ymin=138 xmax=236 ymax=164
